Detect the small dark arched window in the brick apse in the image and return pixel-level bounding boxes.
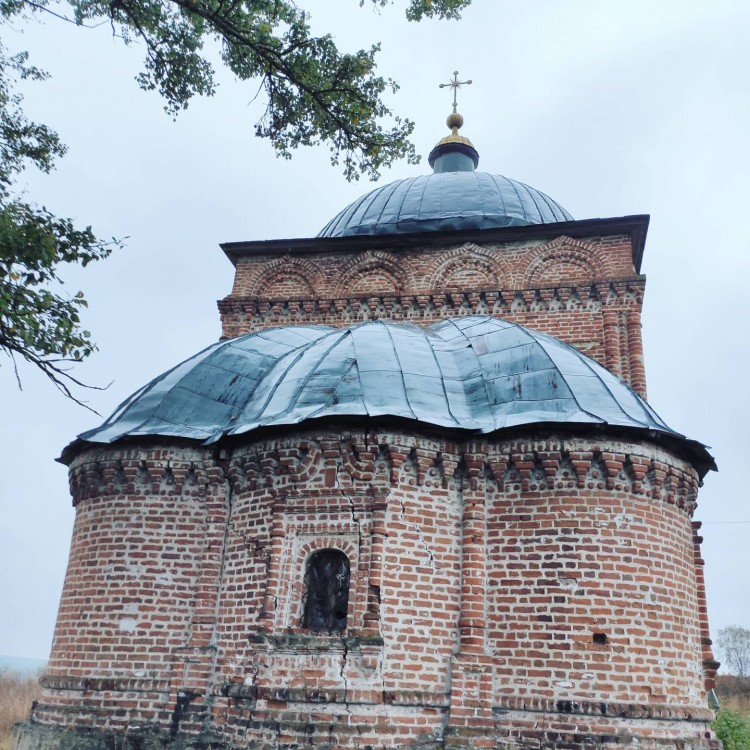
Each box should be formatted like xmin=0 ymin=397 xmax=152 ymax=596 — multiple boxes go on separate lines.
xmin=302 ymin=549 xmax=349 ymax=632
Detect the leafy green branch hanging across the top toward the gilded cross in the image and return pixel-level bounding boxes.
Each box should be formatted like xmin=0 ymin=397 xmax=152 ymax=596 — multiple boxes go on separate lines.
xmin=13 ymin=0 xmax=471 ymax=180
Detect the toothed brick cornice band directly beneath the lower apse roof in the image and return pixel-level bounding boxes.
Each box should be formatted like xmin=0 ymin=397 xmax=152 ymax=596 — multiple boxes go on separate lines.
xmin=70 ymin=432 xmax=699 ymax=514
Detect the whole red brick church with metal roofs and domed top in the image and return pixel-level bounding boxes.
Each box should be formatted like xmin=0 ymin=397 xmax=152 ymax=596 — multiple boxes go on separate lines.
xmin=15 ymin=104 xmax=718 ymax=750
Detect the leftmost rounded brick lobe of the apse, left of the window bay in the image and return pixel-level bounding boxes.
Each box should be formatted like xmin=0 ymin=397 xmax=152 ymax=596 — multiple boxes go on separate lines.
xmin=40 ymin=448 xmax=226 ymax=727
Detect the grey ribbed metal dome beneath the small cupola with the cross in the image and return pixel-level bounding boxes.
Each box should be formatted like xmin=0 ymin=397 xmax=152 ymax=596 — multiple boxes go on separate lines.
xmin=318 ymin=171 xmax=573 ymax=237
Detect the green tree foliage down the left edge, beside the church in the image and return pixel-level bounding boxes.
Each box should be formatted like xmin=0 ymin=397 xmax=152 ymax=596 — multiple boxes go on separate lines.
xmin=0 ymin=41 xmax=118 ymax=403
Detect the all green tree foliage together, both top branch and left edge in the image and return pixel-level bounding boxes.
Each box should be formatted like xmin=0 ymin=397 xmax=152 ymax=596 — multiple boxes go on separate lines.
xmin=0 ymin=0 xmax=471 ymax=403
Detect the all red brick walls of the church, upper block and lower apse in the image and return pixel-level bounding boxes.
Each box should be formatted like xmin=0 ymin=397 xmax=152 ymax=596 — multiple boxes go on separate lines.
xmin=16 ymin=128 xmax=718 ymax=750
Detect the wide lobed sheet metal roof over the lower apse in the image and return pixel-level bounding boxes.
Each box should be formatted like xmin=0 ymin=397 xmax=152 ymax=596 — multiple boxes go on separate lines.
xmin=71 ymin=316 xmax=710 ymax=472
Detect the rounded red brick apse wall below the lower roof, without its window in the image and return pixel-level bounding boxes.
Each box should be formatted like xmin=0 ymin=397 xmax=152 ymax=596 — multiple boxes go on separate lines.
xmin=19 ymin=424 xmax=714 ymax=750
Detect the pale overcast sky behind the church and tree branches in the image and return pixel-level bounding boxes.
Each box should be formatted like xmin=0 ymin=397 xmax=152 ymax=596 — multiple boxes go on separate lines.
xmin=0 ymin=0 xmax=750 ymax=658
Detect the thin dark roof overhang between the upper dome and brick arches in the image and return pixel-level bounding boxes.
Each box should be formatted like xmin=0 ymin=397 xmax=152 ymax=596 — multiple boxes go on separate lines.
xmin=220 ymin=214 xmax=650 ymax=273
